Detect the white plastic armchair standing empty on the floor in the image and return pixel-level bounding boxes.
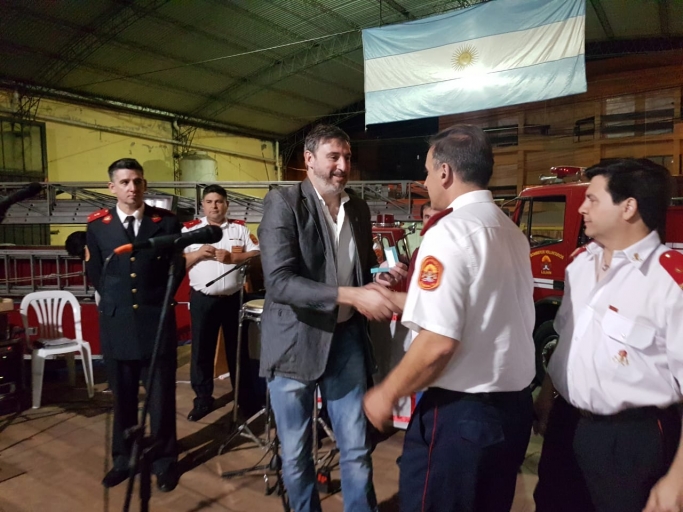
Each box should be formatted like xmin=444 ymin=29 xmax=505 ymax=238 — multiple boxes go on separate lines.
xmin=20 ymin=291 xmax=95 ymax=409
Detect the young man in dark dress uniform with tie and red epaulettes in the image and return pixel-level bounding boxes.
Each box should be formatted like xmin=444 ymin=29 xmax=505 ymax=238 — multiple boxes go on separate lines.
xmin=85 ymin=158 xmax=185 ymax=491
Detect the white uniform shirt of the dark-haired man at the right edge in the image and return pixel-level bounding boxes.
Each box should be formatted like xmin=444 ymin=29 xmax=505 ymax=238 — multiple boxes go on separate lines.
xmin=548 ymin=231 xmax=683 ymax=414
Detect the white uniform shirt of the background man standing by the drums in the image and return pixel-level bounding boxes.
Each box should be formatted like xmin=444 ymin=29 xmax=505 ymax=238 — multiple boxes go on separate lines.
xmin=182 ymin=217 xmax=259 ymax=295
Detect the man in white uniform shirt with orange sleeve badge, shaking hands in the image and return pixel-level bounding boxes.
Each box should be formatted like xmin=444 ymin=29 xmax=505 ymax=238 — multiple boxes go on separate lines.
xmin=364 ymin=125 xmax=534 ymax=512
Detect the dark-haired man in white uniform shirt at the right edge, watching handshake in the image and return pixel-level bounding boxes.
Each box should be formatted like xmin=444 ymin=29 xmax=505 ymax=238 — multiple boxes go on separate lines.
xmin=534 ymin=159 xmax=683 ymax=512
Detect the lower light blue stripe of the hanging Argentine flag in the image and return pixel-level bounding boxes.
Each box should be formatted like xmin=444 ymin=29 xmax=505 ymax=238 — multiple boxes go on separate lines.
xmin=365 ymin=55 xmax=586 ymax=125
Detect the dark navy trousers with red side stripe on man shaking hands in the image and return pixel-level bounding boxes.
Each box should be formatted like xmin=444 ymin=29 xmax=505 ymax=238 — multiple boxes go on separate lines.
xmin=399 ymin=388 xmax=533 ymax=512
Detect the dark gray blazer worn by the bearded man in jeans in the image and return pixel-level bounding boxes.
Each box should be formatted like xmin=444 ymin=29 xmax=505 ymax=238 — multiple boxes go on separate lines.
xmin=258 ymin=179 xmax=377 ymax=381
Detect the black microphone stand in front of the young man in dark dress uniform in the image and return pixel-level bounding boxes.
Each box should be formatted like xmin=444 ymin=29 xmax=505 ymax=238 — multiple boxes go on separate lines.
xmin=123 ymin=254 xmax=175 ymax=512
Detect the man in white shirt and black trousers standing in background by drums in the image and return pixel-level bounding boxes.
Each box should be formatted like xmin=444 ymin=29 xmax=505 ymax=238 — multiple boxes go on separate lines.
xmin=183 ymin=185 xmax=259 ymax=421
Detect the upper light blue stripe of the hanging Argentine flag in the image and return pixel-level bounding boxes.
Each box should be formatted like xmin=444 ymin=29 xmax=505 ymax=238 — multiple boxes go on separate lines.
xmin=363 ymin=0 xmax=586 ymax=60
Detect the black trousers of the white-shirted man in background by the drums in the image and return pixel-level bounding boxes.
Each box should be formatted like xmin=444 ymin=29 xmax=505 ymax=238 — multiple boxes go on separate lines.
xmin=190 ymin=289 xmax=265 ymax=415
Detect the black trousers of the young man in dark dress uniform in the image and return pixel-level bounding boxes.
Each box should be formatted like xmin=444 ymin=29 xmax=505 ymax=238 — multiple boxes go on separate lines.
xmin=105 ymin=354 xmax=178 ymax=474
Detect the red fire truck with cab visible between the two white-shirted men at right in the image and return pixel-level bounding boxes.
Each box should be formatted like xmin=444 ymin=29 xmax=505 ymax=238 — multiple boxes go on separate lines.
xmin=513 ymin=167 xmax=683 ymax=383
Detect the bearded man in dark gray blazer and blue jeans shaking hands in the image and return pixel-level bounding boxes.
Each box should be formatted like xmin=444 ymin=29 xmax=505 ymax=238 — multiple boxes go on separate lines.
xmin=258 ymin=125 xmax=400 ymax=512
